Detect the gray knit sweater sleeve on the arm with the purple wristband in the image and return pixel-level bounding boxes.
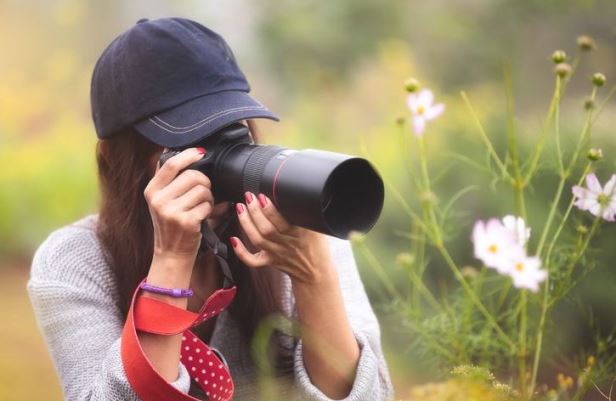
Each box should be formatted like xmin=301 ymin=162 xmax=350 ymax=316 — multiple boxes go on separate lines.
xmin=27 ymin=226 xmax=190 ymax=401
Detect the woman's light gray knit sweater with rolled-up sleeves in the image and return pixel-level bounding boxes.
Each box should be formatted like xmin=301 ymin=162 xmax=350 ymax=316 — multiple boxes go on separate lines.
xmin=27 ymin=215 xmax=393 ymax=401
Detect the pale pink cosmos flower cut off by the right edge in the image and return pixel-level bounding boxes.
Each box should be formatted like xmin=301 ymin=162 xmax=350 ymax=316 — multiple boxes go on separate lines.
xmin=571 ymin=173 xmax=616 ymax=221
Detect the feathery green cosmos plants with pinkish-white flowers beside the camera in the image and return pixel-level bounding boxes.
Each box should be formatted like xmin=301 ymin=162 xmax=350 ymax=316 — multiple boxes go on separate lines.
xmin=352 ymin=36 xmax=616 ymax=400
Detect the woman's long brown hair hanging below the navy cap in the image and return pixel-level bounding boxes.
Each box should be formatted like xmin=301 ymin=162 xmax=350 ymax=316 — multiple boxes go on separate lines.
xmin=96 ymin=124 xmax=292 ymax=373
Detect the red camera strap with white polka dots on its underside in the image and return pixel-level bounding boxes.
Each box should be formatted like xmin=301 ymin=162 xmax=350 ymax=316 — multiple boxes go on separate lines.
xmin=121 ymin=279 xmax=236 ymax=401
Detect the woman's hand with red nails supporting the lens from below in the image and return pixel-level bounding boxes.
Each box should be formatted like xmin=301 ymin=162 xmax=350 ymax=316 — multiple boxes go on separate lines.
xmin=230 ymin=192 xmax=331 ymax=284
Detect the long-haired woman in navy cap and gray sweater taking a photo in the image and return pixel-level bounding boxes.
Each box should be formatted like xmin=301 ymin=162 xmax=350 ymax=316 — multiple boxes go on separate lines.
xmin=27 ymin=18 xmax=392 ymax=400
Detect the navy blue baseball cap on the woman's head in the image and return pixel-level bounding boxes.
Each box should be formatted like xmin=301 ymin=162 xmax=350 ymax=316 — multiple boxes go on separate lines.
xmin=90 ymin=18 xmax=278 ymax=148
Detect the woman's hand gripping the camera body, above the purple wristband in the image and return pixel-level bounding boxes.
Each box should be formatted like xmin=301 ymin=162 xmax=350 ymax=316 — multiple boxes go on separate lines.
xmin=143 ymin=148 xmax=214 ymax=262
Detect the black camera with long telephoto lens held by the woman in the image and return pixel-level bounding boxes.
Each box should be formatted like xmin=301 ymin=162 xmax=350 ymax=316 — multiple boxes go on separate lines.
xmin=161 ymin=123 xmax=385 ymax=239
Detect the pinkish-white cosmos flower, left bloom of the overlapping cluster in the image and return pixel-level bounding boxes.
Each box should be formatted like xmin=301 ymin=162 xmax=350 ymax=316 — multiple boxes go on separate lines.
xmin=472 ymin=219 xmax=524 ymax=274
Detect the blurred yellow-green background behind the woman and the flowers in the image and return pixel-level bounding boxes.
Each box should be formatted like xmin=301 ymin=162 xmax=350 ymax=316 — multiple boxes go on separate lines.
xmin=0 ymin=0 xmax=616 ymax=400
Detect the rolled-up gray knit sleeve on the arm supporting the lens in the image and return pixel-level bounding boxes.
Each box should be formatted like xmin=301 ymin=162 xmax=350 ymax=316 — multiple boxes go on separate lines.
xmin=294 ymin=237 xmax=393 ymax=401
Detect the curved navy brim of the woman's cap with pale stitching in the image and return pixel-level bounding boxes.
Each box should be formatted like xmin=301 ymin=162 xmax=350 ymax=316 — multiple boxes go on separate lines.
xmin=134 ymin=91 xmax=279 ymax=148
